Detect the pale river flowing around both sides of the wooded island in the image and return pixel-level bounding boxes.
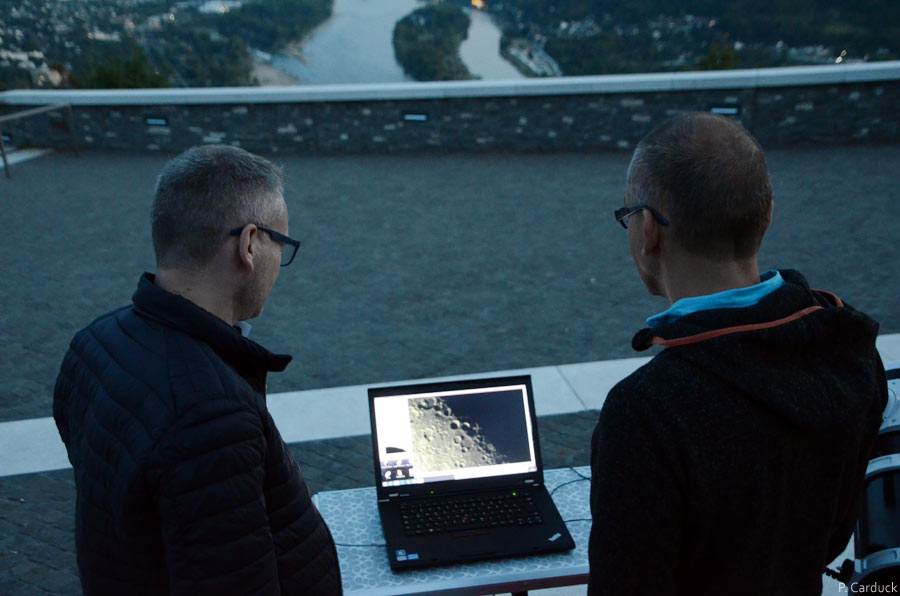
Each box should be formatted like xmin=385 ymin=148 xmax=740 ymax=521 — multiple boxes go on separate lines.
xmin=271 ymin=0 xmax=522 ymax=85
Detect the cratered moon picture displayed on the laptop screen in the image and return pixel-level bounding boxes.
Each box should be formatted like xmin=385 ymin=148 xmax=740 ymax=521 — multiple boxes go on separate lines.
xmin=409 ymin=392 xmax=529 ymax=472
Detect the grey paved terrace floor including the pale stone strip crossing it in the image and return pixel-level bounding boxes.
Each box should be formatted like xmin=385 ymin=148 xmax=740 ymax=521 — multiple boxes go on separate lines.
xmin=0 ymin=145 xmax=900 ymax=596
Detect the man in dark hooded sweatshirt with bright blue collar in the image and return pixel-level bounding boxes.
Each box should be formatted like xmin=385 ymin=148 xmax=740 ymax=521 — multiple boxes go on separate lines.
xmin=589 ymin=113 xmax=887 ymax=596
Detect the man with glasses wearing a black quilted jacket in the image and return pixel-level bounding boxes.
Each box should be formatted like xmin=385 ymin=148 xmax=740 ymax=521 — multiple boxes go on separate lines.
xmin=53 ymin=146 xmax=341 ymax=596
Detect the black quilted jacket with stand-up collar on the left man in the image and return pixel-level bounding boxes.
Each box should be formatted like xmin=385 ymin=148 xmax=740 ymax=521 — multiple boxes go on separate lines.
xmin=53 ymin=274 xmax=341 ymax=596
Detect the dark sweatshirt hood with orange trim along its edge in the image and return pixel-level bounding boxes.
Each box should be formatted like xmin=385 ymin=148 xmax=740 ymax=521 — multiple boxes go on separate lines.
xmin=632 ymin=270 xmax=887 ymax=433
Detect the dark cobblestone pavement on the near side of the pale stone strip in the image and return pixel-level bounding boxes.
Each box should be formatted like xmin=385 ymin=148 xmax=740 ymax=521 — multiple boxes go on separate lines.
xmin=0 ymin=412 xmax=597 ymax=596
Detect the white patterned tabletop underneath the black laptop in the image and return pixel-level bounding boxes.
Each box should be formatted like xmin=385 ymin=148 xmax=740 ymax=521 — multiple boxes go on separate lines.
xmin=313 ymin=467 xmax=591 ymax=596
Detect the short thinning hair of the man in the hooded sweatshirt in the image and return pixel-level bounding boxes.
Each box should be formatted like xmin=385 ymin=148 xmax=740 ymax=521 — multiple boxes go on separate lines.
xmin=627 ymin=112 xmax=772 ymax=259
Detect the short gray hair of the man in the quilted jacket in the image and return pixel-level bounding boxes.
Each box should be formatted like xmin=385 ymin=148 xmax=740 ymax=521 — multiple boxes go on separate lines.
xmin=151 ymin=145 xmax=284 ymax=269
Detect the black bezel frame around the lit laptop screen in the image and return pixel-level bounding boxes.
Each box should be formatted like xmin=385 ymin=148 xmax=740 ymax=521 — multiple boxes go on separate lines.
xmin=369 ymin=375 xmax=544 ymax=501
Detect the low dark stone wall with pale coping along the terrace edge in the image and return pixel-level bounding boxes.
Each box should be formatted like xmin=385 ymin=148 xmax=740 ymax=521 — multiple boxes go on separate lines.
xmin=0 ymin=62 xmax=900 ymax=154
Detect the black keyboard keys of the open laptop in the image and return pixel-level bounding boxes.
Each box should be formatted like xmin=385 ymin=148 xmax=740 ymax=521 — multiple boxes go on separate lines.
xmin=400 ymin=493 xmax=543 ymax=536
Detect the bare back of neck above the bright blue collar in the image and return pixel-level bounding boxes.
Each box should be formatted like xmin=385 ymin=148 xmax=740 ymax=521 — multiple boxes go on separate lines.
xmin=662 ymin=257 xmax=760 ymax=304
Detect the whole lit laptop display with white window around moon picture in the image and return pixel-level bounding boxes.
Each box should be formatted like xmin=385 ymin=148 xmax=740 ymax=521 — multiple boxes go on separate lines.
xmin=370 ymin=378 xmax=538 ymax=487
